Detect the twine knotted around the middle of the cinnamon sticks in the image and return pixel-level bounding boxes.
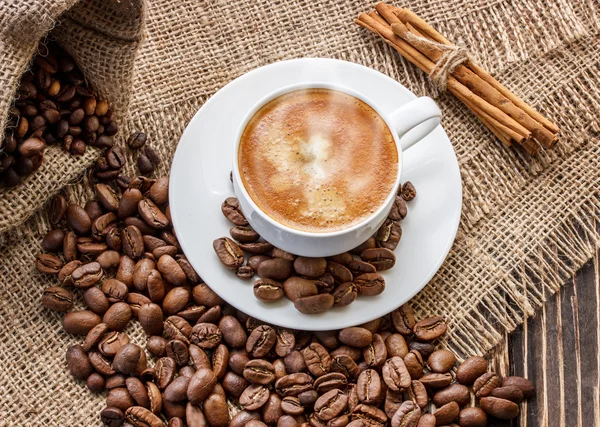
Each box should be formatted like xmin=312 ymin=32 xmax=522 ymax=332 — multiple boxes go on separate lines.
xmin=391 ymin=24 xmax=473 ymax=92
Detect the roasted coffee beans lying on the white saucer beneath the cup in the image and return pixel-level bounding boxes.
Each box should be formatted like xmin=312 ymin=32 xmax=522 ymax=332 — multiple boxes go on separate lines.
xmin=213 ymin=181 xmax=417 ymax=314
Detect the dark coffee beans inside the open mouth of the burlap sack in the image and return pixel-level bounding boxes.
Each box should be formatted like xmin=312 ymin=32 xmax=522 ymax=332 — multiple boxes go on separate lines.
xmin=0 ymin=43 xmax=118 ymax=187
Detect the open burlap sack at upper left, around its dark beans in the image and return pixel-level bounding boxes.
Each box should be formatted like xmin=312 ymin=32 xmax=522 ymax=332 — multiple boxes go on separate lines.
xmin=0 ymin=0 xmax=144 ymax=232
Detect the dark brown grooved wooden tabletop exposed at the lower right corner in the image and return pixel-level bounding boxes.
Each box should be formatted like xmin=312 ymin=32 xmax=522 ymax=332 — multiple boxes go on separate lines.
xmin=489 ymin=253 xmax=600 ymax=427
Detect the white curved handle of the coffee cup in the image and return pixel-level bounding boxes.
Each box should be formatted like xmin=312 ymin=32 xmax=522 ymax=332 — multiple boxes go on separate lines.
xmin=389 ymin=96 xmax=442 ymax=151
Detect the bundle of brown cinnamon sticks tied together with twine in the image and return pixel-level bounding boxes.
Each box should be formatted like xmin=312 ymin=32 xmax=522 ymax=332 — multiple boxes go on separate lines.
xmin=355 ymin=3 xmax=558 ymax=154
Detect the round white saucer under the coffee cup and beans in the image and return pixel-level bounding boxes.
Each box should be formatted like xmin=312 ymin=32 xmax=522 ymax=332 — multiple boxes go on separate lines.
xmin=169 ymin=58 xmax=462 ymax=330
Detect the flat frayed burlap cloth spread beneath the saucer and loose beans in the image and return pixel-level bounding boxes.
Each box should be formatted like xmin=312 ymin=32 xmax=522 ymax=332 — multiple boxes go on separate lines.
xmin=0 ymin=0 xmax=600 ymax=426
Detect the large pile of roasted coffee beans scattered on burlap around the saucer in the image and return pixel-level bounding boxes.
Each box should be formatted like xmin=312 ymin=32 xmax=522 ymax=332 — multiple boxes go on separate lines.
xmin=36 ymin=163 xmax=534 ymax=427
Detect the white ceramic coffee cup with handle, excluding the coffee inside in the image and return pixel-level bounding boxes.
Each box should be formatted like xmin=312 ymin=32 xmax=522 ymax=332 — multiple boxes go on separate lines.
xmin=232 ymin=82 xmax=442 ymax=257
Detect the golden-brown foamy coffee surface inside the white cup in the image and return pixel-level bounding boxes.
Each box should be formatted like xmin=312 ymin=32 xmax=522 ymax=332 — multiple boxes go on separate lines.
xmin=238 ymin=89 xmax=398 ymax=232
